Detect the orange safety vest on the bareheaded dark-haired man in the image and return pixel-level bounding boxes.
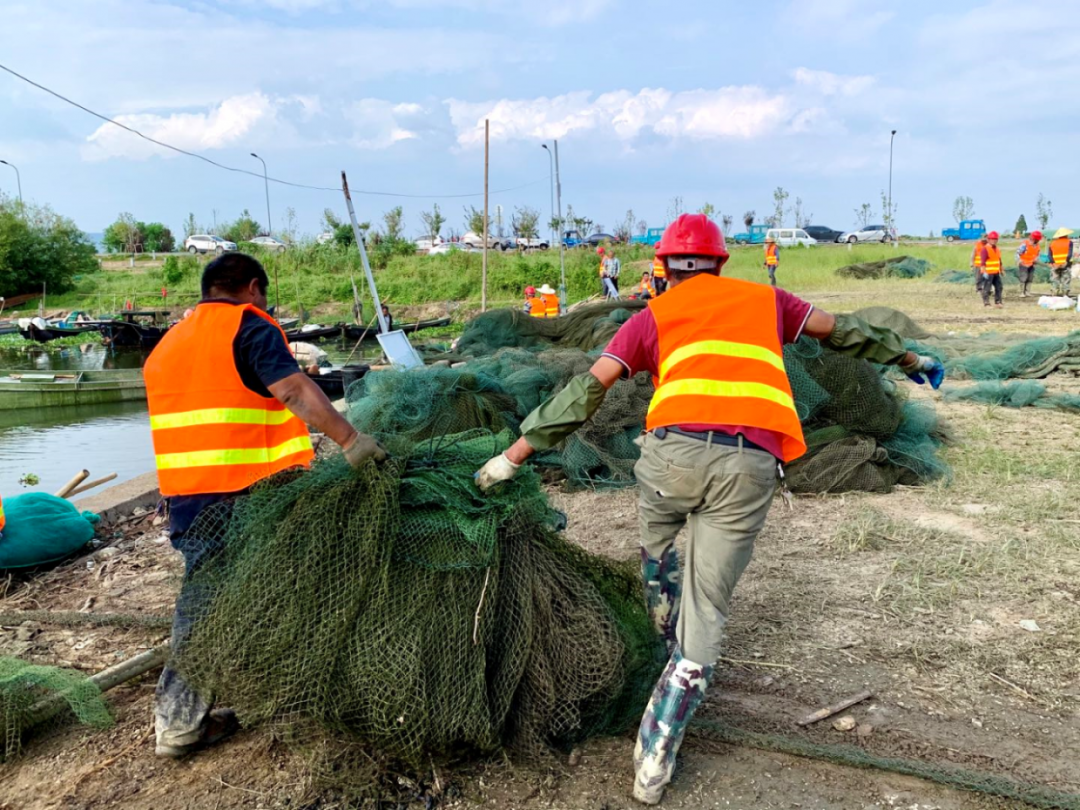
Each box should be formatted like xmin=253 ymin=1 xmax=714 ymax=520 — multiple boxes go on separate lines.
xmin=143 ymin=303 xmax=314 ymax=497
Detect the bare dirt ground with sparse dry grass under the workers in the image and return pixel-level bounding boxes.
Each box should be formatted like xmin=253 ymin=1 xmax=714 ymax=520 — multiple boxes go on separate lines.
xmin=0 ymin=291 xmax=1080 ymax=810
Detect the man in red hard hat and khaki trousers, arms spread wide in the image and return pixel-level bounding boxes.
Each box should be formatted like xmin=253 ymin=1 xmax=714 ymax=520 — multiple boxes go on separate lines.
xmin=476 ymin=214 xmax=945 ymax=805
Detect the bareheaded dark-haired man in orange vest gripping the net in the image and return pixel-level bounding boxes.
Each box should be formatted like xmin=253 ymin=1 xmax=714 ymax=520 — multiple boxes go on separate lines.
xmin=143 ymin=253 xmax=387 ymax=757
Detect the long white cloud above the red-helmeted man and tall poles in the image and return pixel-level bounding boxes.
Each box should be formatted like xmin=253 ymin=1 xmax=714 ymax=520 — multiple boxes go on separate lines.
xmin=446 ymin=86 xmax=793 ymax=147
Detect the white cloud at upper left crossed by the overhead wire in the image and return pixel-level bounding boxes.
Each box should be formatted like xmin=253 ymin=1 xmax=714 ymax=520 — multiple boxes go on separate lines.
xmin=83 ymin=93 xmax=279 ymax=160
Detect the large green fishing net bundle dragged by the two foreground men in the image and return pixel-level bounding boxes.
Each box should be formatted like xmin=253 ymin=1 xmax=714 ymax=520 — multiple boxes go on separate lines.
xmin=175 ymin=434 xmax=662 ymax=765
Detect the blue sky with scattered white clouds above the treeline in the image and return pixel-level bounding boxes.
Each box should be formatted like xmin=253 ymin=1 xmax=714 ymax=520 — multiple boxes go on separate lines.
xmin=0 ymin=0 xmax=1080 ymax=240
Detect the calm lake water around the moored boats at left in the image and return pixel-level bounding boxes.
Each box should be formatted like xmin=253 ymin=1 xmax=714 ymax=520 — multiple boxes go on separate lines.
xmin=0 ymin=330 xmax=436 ymax=497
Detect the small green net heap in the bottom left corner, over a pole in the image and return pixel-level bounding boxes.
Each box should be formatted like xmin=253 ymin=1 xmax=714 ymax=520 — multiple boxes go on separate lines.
xmin=0 ymin=657 xmax=112 ymax=761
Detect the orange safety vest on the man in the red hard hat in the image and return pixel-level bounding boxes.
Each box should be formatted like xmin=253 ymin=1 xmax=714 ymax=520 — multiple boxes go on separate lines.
xmin=645 ymin=273 xmax=807 ymax=461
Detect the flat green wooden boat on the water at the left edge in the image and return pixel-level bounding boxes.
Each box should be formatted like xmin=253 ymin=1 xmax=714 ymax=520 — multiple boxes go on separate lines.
xmin=0 ymin=368 xmax=146 ymax=410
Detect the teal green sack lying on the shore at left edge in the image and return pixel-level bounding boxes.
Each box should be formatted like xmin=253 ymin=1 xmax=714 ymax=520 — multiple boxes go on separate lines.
xmin=0 ymin=492 xmax=102 ymax=569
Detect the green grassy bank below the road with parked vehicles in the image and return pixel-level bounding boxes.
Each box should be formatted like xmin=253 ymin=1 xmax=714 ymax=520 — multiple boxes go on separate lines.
xmin=14 ymin=237 xmax=993 ymax=320
